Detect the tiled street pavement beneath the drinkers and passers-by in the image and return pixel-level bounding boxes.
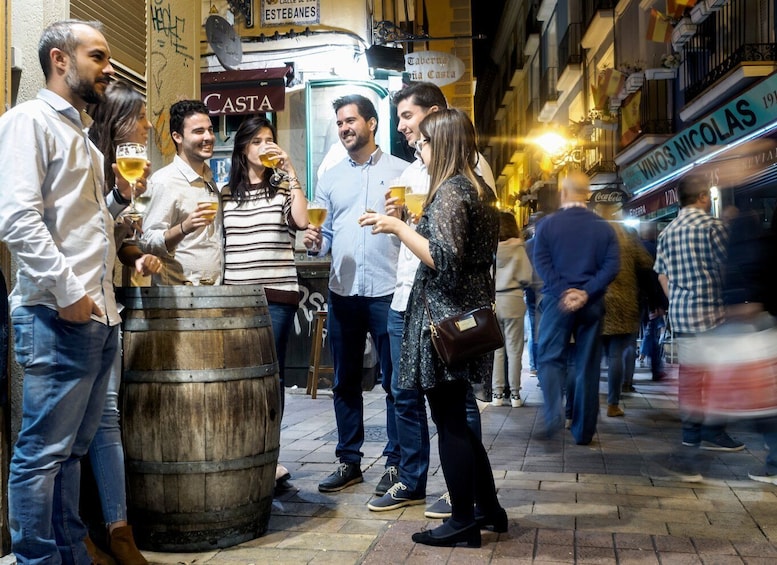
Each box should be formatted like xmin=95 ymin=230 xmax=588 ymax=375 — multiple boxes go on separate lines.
xmin=144 ymin=365 xmax=777 ymax=565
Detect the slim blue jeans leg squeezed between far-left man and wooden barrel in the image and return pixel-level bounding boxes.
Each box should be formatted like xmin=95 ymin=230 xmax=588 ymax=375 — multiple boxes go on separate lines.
xmin=89 ymin=331 xmax=127 ymax=525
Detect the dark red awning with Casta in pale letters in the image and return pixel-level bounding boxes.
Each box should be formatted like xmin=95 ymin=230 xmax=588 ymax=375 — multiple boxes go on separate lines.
xmin=200 ymin=67 xmax=291 ymax=116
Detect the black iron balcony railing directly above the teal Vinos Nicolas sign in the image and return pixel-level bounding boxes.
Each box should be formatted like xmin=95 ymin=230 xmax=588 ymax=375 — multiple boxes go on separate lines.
xmin=683 ymin=0 xmax=777 ymax=104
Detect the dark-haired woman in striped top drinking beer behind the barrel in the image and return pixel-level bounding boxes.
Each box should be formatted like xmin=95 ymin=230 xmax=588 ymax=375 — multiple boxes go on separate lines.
xmin=222 ymin=116 xmax=308 ymax=414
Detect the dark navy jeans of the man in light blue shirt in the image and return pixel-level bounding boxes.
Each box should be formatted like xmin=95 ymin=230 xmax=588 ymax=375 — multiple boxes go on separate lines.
xmin=327 ymin=292 xmax=399 ymax=466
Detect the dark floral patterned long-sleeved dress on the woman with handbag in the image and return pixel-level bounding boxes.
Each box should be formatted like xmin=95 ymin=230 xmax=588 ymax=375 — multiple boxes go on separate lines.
xmin=399 ymin=175 xmax=499 ymax=390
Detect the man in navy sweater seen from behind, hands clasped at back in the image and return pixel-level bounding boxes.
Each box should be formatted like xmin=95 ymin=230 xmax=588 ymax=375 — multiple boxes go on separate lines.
xmin=533 ymin=172 xmax=620 ymax=445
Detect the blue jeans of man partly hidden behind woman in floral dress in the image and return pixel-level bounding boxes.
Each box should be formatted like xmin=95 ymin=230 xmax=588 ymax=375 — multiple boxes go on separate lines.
xmin=386 ymin=309 xmax=482 ymax=497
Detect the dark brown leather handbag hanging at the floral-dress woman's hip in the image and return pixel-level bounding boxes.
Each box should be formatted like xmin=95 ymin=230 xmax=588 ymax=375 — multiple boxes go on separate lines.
xmin=424 ymin=293 xmax=504 ymax=368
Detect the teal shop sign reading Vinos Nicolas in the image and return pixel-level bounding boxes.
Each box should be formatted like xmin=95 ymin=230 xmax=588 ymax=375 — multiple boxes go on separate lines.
xmin=621 ymin=73 xmax=777 ymax=191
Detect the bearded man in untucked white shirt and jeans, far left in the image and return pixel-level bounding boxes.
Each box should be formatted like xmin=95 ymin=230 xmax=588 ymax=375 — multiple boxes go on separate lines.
xmin=0 ymin=20 xmax=120 ymax=564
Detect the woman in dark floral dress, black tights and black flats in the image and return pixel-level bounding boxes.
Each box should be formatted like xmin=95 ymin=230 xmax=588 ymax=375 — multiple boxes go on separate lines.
xmin=359 ymin=109 xmax=507 ymax=547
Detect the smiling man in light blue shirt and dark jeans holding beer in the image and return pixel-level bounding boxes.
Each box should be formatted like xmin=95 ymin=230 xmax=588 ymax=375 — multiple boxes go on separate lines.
xmin=304 ymin=95 xmax=407 ymax=495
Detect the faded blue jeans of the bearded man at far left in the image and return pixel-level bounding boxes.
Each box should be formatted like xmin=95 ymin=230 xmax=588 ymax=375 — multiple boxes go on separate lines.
xmin=8 ymin=306 xmax=118 ymax=565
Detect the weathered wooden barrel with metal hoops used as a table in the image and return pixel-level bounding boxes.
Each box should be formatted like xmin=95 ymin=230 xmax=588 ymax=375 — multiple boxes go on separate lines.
xmin=118 ymin=285 xmax=281 ymax=552
